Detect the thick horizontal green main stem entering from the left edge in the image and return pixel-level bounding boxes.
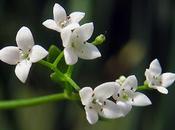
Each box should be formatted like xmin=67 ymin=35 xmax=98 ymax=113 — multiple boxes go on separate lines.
xmin=0 ymin=93 xmax=67 ymax=109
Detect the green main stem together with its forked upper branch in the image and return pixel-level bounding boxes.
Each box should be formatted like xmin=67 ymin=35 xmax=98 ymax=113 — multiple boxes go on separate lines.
xmin=0 ymin=52 xmax=80 ymax=109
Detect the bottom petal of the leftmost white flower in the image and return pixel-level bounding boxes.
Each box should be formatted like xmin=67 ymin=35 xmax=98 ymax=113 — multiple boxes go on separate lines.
xmin=15 ymin=60 xmax=32 ymax=83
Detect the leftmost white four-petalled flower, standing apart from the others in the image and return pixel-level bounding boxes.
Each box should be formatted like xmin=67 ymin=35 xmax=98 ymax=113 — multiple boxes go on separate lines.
xmin=0 ymin=27 xmax=48 ymax=83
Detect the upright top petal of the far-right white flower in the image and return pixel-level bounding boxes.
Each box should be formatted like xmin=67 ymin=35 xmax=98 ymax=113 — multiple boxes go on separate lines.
xmin=149 ymin=59 xmax=162 ymax=76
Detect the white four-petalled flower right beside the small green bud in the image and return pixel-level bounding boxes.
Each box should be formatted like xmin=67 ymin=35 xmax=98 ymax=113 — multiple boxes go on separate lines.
xmin=61 ymin=23 xmax=101 ymax=65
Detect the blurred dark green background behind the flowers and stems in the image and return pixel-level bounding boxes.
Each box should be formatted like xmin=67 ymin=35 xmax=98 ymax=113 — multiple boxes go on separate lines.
xmin=0 ymin=0 xmax=175 ymax=130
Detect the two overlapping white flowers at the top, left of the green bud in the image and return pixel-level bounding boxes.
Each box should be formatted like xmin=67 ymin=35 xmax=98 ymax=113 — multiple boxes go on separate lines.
xmin=43 ymin=4 xmax=101 ymax=65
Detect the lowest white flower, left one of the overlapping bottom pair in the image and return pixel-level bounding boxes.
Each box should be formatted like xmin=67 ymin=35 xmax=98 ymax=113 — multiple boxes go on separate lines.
xmin=79 ymin=82 xmax=123 ymax=124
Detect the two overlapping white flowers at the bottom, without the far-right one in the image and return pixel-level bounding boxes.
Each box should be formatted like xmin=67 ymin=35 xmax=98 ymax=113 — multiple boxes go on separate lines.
xmin=79 ymin=75 xmax=151 ymax=124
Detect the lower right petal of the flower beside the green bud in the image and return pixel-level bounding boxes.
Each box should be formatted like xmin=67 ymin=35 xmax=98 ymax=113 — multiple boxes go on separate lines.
xmin=76 ymin=43 xmax=101 ymax=60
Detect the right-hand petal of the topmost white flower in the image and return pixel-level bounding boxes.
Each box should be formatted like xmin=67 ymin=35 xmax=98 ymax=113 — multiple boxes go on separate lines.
xmin=69 ymin=12 xmax=85 ymax=23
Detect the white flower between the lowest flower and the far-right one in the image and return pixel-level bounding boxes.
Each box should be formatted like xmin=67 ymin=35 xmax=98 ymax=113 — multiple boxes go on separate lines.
xmin=113 ymin=75 xmax=151 ymax=115
